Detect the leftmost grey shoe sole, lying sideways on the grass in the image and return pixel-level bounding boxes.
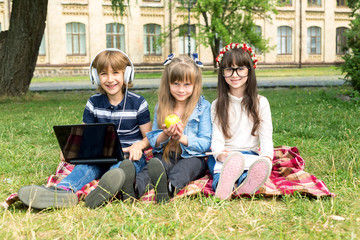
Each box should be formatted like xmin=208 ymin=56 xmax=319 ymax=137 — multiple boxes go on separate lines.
xmin=18 ymin=185 xmax=79 ymax=209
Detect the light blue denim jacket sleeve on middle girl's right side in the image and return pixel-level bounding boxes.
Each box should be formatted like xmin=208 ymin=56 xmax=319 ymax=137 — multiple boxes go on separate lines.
xmin=181 ymin=100 xmax=211 ymax=155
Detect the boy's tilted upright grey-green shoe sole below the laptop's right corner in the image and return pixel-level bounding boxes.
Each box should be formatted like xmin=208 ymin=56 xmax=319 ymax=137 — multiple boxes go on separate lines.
xmin=85 ymin=168 xmax=125 ymax=208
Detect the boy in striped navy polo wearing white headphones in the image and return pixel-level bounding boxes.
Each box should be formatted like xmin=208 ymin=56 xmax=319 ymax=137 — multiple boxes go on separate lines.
xmin=18 ymin=49 xmax=151 ymax=209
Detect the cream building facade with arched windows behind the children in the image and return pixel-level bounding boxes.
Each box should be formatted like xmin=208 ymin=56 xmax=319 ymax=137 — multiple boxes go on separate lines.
xmin=0 ymin=0 xmax=351 ymax=76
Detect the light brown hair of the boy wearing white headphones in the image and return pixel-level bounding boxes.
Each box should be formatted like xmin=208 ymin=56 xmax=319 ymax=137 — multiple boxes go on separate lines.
xmin=93 ymin=50 xmax=133 ymax=94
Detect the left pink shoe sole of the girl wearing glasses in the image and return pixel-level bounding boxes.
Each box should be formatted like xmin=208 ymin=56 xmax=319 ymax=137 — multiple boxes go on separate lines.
xmin=215 ymin=153 xmax=245 ymax=200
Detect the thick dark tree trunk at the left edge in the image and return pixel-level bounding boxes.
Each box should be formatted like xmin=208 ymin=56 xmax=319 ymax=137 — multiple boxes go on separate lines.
xmin=0 ymin=0 xmax=48 ymax=96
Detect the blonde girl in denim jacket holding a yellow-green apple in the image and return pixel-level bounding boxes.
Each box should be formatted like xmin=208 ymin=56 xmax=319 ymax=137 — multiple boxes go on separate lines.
xmin=136 ymin=53 xmax=211 ymax=202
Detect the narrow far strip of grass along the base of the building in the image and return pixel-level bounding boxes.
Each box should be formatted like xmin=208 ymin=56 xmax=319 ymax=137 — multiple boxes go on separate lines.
xmin=31 ymin=66 xmax=342 ymax=83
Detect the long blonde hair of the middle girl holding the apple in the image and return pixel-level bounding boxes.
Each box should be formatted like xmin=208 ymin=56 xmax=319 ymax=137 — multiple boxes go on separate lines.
xmin=157 ymin=57 xmax=202 ymax=162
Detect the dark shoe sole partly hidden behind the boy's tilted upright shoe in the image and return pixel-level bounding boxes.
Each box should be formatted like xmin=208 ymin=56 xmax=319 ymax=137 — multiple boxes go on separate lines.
xmin=119 ymin=160 xmax=136 ymax=200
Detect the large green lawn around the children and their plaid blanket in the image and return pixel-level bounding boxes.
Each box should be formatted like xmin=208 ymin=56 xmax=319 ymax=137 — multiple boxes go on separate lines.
xmin=0 ymin=88 xmax=360 ymax=239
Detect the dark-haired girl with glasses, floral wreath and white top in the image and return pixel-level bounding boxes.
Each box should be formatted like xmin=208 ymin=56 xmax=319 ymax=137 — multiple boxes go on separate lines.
xmin=207 ymin=43 xmax=273 ymax=199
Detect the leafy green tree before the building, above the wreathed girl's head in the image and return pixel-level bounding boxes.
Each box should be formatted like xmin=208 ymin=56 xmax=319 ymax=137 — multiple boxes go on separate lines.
xmin=193 ymin=0 xmax=276 ymax=66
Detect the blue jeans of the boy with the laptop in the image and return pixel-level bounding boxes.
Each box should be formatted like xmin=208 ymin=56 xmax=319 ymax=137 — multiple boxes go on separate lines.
xmin=57 ymin=154 xmax=146 ymax=192
